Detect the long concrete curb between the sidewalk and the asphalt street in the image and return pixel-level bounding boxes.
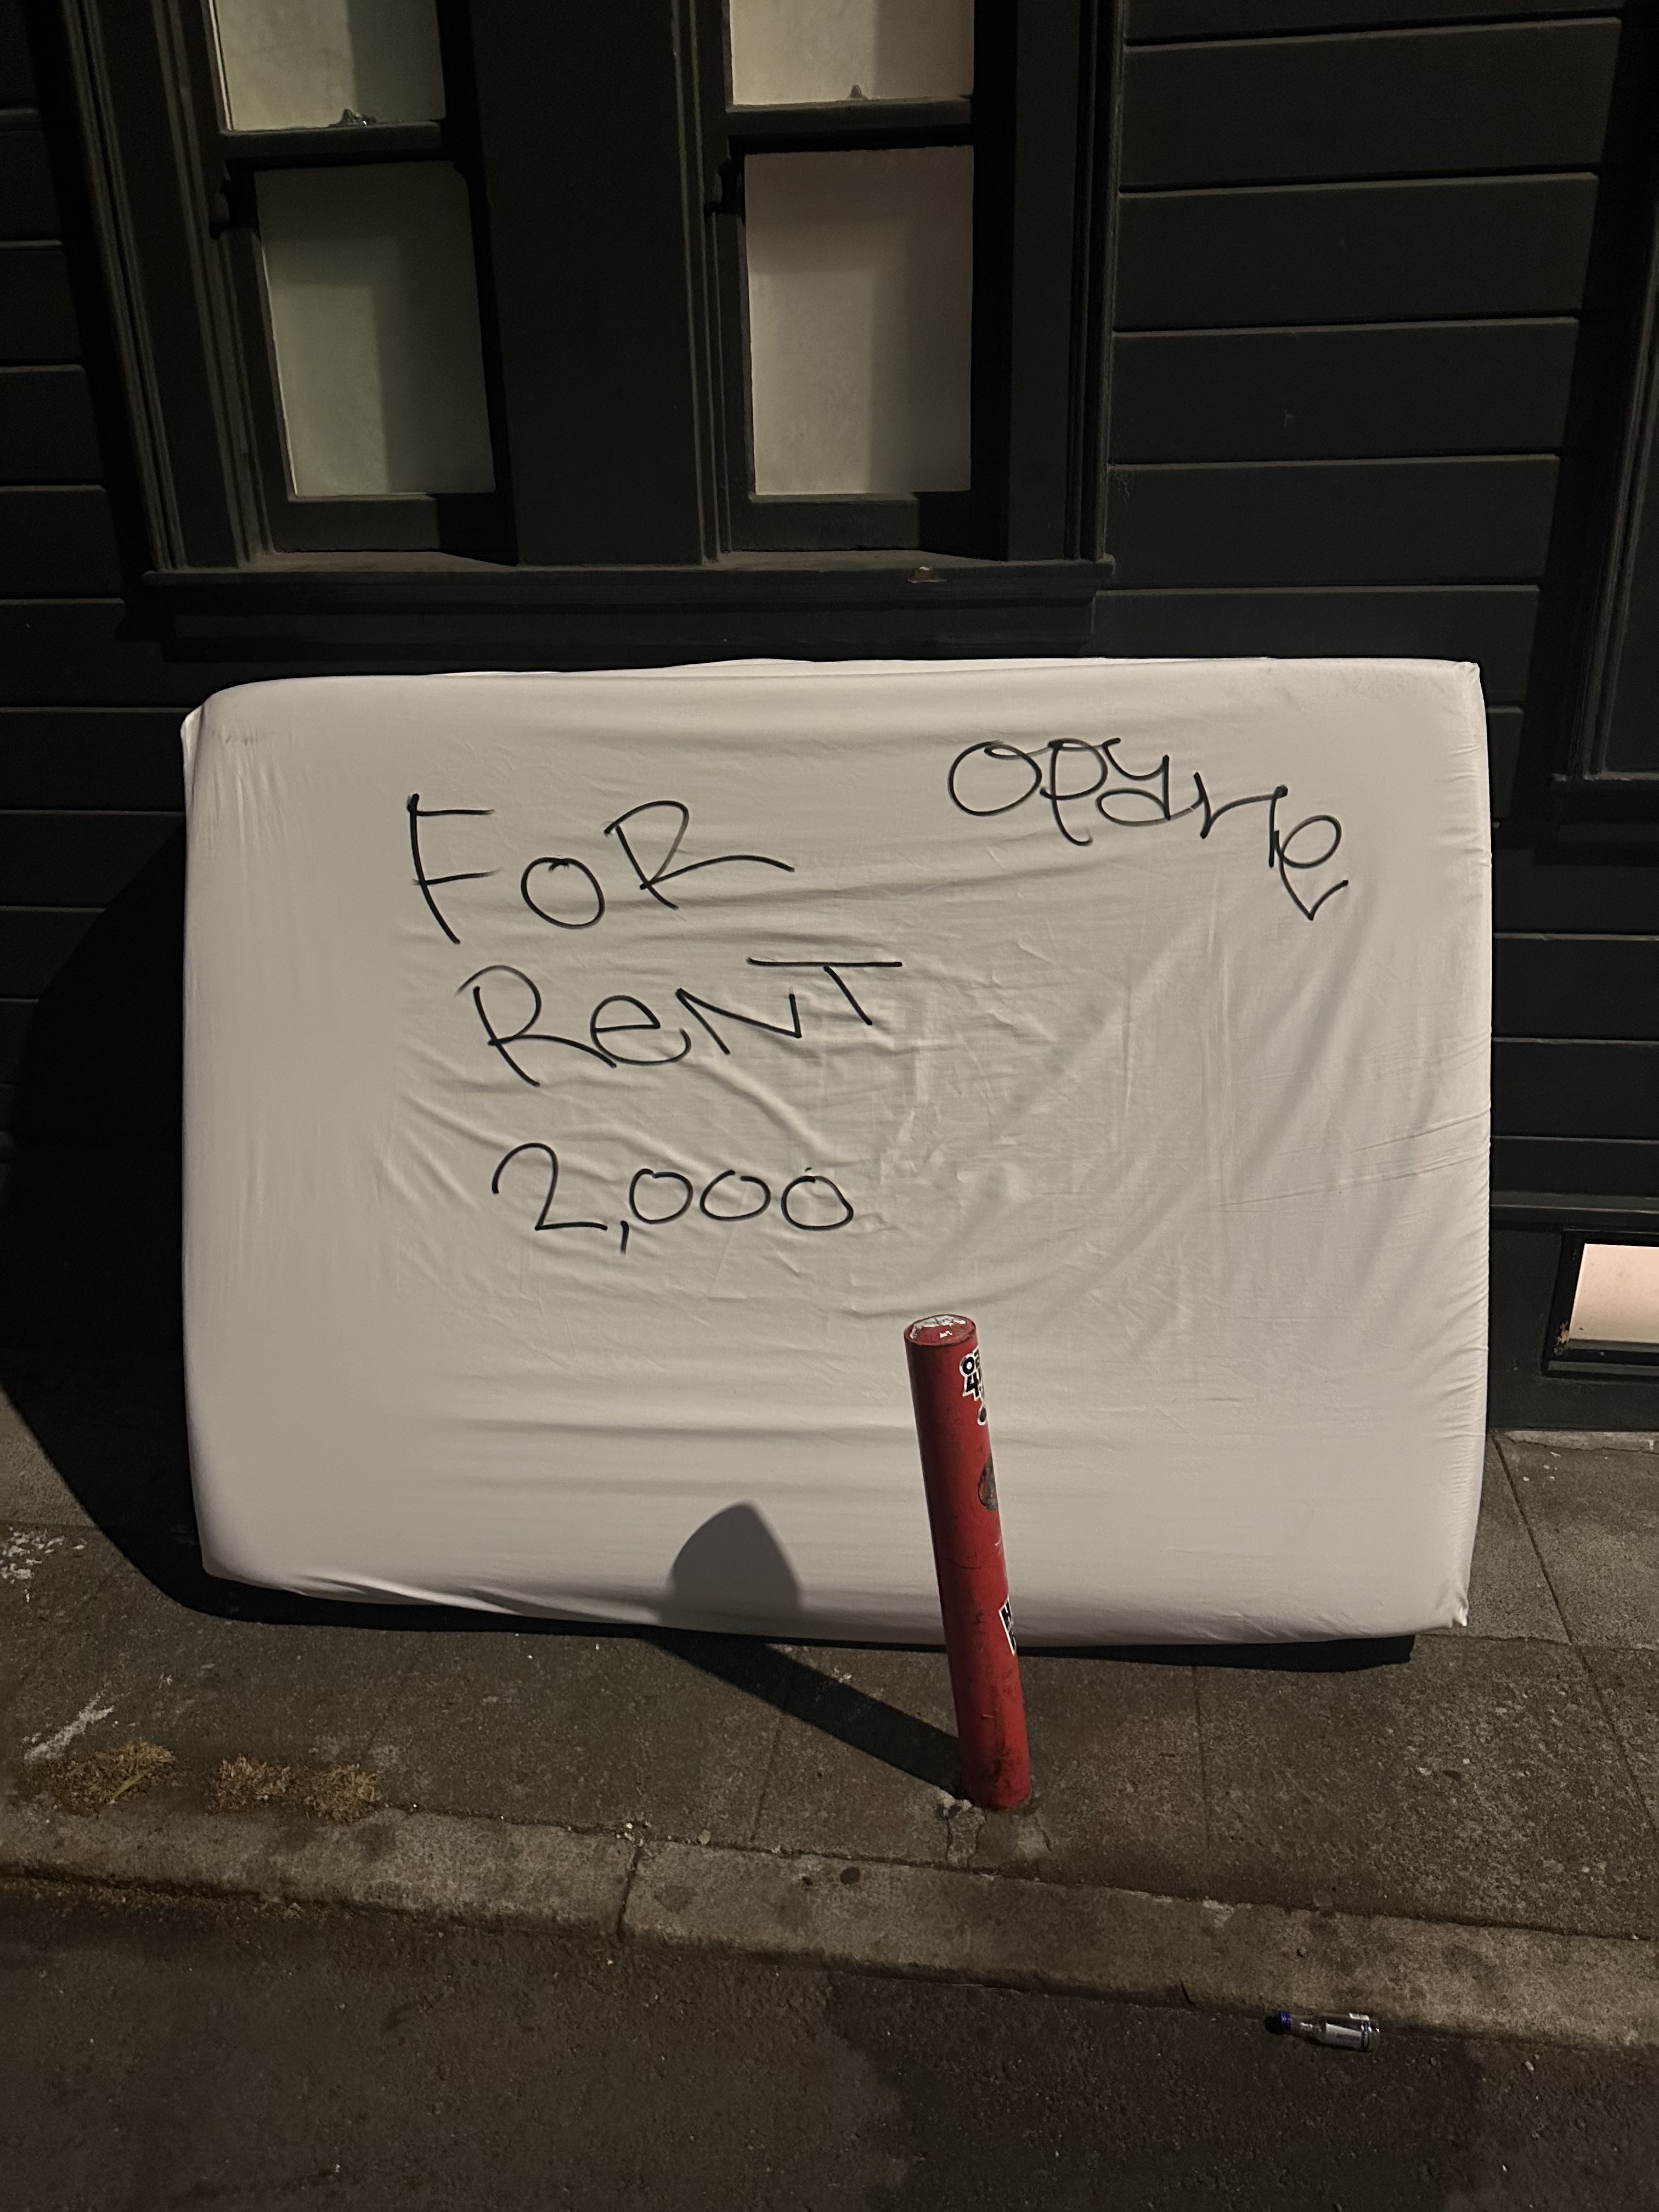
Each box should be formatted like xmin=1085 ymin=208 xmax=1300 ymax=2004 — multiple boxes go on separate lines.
xmin=0 ymin=1801 xmax=1659 ymax=2049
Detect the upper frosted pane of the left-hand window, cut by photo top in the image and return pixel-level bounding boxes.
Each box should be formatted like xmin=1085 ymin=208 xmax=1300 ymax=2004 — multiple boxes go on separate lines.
xmin=215 ymin=0 xmax=444 ymax=131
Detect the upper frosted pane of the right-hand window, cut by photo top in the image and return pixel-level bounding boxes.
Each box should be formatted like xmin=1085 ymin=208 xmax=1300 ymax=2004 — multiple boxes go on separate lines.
xmin=730 ymin=0 xmax=973 ymax=106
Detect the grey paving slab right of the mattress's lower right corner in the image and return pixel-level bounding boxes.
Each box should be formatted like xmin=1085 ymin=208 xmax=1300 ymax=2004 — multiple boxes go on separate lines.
xmin=1502 ymin=1436 xmax=1659 ymax=1650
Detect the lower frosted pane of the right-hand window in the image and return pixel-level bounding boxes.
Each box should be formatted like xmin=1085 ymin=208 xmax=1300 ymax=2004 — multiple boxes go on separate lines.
xmin=743 ymin=146 xmax=973 ymax=493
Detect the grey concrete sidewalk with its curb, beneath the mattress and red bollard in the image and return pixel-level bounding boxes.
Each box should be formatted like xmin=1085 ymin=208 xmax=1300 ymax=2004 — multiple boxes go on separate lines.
xmin=0 ymin=1369 xmax=1659 ymax=2042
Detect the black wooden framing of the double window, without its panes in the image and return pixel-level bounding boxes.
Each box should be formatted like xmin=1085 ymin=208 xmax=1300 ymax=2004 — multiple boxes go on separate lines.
xmin=60 ymin=0 xmax=1110 ymax=641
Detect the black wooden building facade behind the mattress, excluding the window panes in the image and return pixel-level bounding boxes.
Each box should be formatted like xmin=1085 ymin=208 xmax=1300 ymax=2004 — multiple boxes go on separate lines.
xmin=0 ymin=0 xmax=1659 ymax=1429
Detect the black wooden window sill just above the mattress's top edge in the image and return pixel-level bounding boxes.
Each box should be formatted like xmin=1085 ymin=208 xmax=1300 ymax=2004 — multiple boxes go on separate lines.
xmin=135 ymin=553 xmax=1113 ymax=670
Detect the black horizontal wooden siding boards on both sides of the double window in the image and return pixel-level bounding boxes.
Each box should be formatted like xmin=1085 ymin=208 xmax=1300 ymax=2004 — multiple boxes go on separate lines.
xmin=0 ymin=0 xmax=1659 ymax=1411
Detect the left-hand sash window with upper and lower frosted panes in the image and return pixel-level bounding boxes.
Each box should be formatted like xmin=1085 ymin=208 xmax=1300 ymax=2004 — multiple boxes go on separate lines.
xmin=177 ymin=0 xmax=511 ymax=557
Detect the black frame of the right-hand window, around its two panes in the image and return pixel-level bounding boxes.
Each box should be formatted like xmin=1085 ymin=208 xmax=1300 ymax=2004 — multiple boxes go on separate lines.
xmin=692 ymin=0 xmax=1106 ymax=560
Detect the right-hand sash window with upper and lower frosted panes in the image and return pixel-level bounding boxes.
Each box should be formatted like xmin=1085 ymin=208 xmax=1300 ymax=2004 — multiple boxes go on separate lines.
xmin=703 ymin=0 xmax=986 ymax=551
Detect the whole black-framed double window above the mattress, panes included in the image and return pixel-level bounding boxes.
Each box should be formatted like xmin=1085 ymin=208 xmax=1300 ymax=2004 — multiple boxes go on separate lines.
xmin=69 ymin=0 xmax=1119 ymax=614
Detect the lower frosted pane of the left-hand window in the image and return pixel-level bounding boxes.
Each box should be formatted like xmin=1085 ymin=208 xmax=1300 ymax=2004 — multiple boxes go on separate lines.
xmin=259 ymin=161 xmax=493 ymax=498
